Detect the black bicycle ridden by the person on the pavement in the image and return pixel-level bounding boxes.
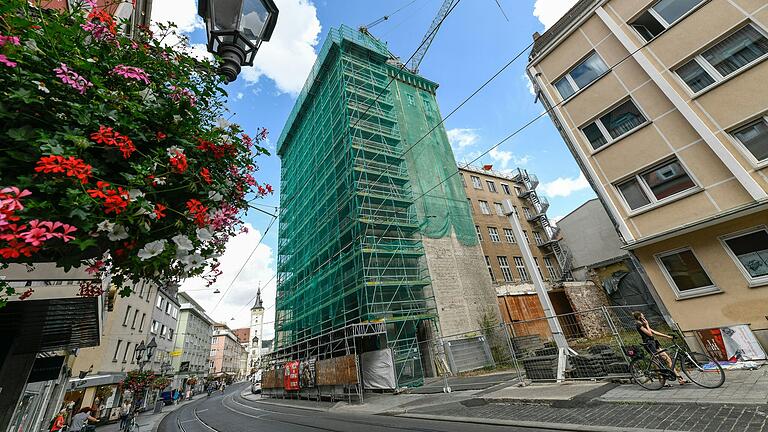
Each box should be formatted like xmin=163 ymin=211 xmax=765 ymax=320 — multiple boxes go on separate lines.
xmin=626 ymin=336 xmax=725 ymax=390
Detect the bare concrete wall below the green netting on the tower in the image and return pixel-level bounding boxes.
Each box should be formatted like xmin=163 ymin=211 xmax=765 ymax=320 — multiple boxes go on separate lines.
xmin=422 ymin=233 xmax=501 ymax=336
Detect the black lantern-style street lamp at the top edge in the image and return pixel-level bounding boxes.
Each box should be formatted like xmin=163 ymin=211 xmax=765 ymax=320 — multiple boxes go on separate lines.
xmin=197 ymin=0 xmax=279 ymax=82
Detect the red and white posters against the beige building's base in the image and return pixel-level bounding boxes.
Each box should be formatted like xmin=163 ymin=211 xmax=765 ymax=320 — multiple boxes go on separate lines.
xmin=696 ymin=324 xmax=767 ymax=362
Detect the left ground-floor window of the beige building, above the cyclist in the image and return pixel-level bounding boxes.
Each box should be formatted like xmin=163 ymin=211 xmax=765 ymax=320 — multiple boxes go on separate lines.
xmin=656 ymin=248 xmax=719 ymax=297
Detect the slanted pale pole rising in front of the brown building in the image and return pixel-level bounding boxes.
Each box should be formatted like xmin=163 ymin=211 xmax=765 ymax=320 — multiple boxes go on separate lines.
xmin=504 ymin=199 xmax=568 ymax=381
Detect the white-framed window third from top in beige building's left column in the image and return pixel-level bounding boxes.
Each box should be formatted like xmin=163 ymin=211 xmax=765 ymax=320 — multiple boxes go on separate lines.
xmin=616 ymin=159 xmax=696 ymax=210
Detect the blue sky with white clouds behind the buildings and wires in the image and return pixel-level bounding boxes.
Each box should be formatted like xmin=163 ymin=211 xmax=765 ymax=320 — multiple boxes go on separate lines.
xmin=153 ymin=0 xmax=594 ymax=327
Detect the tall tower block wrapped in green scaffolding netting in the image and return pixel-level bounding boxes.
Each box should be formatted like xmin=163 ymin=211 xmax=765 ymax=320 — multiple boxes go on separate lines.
xmin=275 ymin=26 xmax=498 ymax=386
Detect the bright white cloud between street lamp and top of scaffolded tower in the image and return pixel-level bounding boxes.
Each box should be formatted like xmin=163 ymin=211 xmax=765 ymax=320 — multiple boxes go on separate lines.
xmin=241 ymin=0 xmax=322 ymax=95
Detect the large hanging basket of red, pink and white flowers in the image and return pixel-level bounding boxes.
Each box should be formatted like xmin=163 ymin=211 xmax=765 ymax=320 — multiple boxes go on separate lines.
xmin=0 ymin=0 xmax=272 ymax=307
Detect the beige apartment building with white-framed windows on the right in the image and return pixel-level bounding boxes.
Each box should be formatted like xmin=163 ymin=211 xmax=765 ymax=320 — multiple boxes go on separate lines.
xmin=528 ymin=0 xmax=768 ymax=352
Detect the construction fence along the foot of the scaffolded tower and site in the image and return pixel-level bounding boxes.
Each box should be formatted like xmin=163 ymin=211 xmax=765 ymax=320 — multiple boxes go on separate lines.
xmin=262 ymin=305 xmax=674 ymax=401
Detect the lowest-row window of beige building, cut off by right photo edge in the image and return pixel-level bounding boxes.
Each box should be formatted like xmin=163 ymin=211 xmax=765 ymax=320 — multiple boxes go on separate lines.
xmin=723 ymin=228 xmax=768 ymax=286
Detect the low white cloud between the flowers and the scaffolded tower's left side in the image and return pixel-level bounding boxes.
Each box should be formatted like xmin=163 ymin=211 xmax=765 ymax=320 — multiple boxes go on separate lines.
xmin=181 ymin=224 xmax=275 ymax=339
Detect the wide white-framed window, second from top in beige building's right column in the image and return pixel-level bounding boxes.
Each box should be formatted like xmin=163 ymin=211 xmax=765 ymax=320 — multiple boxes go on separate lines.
xmin=675 ymin=24 xmax=768 ymax=93
